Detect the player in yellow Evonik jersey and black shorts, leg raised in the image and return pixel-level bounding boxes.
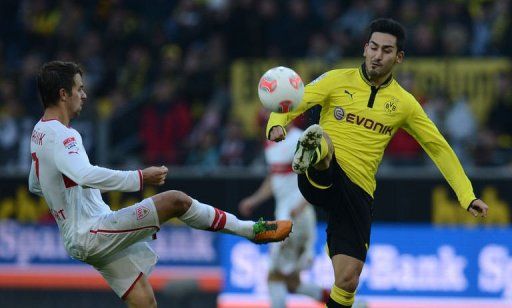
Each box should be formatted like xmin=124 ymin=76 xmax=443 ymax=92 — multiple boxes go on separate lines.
xmin=267 ymin=19 xmax=488 ymax=308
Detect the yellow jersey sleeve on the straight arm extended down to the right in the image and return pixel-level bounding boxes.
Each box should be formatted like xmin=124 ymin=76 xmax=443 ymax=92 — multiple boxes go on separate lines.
xmin=403 ymin=98 xmax=476 ymax=209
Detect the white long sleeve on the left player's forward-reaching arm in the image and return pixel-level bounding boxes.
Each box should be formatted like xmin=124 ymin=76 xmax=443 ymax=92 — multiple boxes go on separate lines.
xmin=54 ymin=133 xmax=142 ymax=191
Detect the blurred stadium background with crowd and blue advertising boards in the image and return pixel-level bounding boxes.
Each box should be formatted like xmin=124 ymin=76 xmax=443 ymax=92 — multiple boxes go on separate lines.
xmin=0 ymin=0 xmax=512 ymax=307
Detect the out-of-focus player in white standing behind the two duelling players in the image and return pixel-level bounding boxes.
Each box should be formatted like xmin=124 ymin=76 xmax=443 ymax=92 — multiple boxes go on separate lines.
xmin=239 ymin=115 xmax=329 ymax=308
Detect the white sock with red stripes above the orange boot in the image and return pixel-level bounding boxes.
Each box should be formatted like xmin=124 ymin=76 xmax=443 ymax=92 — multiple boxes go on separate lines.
xmin=178 ymin=199 xmax=254 ymax=239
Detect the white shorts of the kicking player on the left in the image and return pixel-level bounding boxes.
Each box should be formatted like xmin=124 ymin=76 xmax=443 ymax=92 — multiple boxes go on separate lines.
xmin=85 ymin=198 xmax=160 ymax=299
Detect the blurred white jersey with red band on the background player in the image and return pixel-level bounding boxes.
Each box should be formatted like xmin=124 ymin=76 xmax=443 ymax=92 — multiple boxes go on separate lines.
xmin=265 ymin=127 xmax=303 ymax=219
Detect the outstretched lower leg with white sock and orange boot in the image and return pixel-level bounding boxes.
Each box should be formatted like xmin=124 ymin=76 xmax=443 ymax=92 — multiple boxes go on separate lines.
xmin=152 ymin=190 xmax=292 ymax=244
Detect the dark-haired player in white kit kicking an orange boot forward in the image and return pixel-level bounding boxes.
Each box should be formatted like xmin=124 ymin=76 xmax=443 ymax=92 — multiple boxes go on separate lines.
xmin=29 ymin=61 xmax=291 ymax=307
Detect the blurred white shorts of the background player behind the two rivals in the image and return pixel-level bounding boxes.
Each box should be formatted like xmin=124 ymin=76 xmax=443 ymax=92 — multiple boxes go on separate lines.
xmin=269 ymin=205 xmax=316 ymax=275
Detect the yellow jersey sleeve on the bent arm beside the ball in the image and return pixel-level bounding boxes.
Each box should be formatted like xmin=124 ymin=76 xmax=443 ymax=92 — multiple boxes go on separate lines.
xmin=266 ymin=72 xmax=330 ymax=138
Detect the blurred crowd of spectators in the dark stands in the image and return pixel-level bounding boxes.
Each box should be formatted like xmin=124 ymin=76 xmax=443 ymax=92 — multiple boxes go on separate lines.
xmin=0 ymin=0 xmax=512 ymax=171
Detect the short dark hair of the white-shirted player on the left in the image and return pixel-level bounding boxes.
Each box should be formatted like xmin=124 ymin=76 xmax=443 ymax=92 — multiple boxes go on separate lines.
xmin=37 ymin=61 xmax=83 ymax=109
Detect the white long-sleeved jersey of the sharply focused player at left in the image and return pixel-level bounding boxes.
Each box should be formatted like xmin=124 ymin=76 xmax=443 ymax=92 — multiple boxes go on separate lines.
xmin=29 ymin=120 xmax=142 ymax=259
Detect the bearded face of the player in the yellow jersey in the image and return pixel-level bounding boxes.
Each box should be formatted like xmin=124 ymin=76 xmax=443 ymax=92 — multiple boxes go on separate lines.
xmin=364 ymin=32 xmax=404 ymax=79
